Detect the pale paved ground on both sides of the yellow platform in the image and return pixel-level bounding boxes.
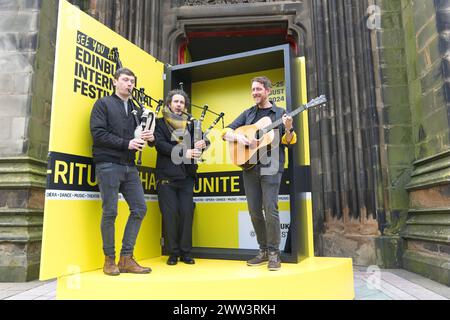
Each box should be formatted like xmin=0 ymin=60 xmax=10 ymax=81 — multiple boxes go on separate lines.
xmin=0 ymin=266 xmax=450 ymax=300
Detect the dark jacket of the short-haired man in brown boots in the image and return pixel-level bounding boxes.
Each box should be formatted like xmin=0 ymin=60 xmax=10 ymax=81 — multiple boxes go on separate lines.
xmin=90 ymin=94 xmax=141 ymax=165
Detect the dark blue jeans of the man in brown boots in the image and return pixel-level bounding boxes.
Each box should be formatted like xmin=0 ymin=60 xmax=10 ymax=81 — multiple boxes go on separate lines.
xmin=95 ymin=162 xmax=147 ymax=257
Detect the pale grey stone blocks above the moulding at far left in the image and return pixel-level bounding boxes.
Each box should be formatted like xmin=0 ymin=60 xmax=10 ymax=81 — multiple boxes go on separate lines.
xmin=0 ymin=0 xmax=40 ymax=156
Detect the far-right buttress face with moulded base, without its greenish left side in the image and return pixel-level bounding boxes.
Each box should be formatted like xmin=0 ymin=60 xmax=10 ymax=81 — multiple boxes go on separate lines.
xmin=401 ymin=0 xmax=450 ymax=285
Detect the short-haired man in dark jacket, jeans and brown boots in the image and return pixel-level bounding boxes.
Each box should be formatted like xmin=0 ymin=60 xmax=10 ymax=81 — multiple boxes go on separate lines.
xmin=90 ymin=68 xmax=155 ymax=276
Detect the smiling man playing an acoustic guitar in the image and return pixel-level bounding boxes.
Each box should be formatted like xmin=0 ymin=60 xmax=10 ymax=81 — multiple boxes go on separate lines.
xmin=223 ymin=77 xmax=297 ymax=271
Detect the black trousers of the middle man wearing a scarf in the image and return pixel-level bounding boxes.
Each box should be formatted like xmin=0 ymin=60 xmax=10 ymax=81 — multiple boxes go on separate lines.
xmin=158 ymin=177 xmax=195 ymax=256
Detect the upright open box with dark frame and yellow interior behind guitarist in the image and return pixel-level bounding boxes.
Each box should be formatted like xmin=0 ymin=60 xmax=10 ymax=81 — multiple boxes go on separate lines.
xmin=165 ymin=45 xmax=314 ymax=263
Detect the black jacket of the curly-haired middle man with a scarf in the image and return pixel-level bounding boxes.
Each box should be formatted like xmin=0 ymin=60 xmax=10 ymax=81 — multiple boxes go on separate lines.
xmin=155 ymin=118 xmax=198 ymax=181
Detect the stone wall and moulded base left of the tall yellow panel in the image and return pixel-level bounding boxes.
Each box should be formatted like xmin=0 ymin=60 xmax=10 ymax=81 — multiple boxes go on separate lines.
xmin=0 ymin=0 xmax=57 ymax=282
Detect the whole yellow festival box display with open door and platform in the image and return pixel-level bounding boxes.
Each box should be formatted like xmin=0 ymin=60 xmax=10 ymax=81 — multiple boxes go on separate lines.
xmin=40 ymin=0 xmax=354 ymax=300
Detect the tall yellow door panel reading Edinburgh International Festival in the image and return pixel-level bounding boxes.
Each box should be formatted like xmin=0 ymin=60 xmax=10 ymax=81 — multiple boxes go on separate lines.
xmin=40 ymin=0 xmax=164 ymax=280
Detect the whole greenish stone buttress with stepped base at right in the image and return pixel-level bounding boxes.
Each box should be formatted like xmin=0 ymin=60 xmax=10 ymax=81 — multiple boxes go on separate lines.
xmin=378 ymin=0 xmax=450 ymax=284
